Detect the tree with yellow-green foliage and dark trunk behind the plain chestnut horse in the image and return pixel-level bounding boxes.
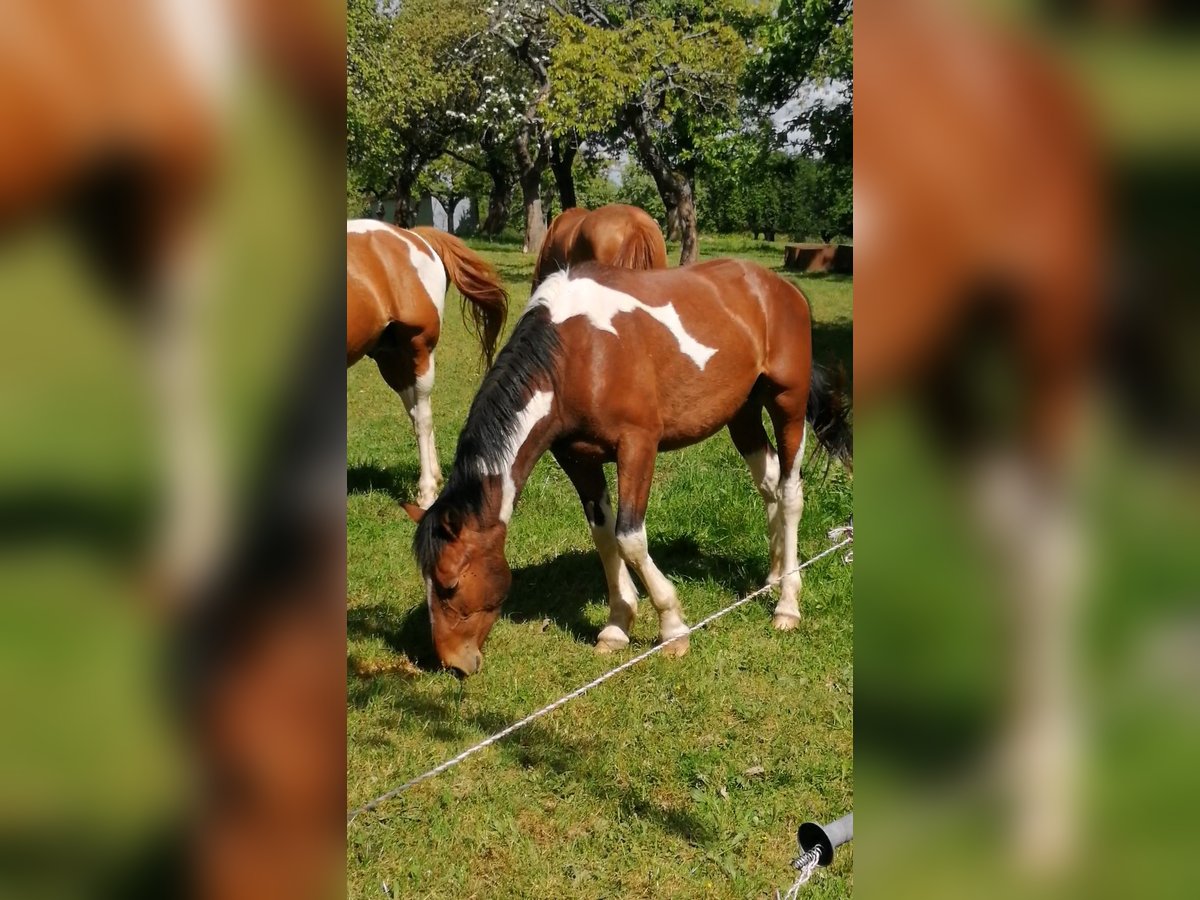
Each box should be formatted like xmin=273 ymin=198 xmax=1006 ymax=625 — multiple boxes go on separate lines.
xmin=547 ymin=0 xmax=761 ymax=263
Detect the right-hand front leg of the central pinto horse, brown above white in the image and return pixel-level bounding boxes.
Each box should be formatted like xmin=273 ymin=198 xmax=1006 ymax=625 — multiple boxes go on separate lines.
xmin=617 ymin=432 xmax=688 ymax=656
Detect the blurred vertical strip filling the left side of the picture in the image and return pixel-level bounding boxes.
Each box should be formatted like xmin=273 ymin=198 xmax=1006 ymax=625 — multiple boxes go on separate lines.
xmin=0 ymin=0 xmax=344 ymax=896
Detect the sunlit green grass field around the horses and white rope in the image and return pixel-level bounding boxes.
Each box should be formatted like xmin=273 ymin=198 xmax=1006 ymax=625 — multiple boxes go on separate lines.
xmin=347 ymin=239 xmax=854 ymax=898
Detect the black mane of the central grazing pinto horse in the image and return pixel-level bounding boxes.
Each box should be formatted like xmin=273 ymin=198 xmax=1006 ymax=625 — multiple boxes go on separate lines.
xmin=413 ymin=306 xmax=559 ymax=574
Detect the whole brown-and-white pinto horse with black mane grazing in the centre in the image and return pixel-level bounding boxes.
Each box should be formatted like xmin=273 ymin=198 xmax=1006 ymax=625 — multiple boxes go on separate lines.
xmin=406 ymin=259 xmax=850 ymax=674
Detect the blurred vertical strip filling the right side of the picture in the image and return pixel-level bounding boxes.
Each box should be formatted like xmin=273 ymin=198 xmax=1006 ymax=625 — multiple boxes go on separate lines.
xmin=854 ymin=0 xmax=1200 ymax=898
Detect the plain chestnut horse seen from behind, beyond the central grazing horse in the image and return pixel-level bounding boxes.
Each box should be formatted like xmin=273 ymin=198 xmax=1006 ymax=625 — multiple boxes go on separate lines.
xmin=533 ymin=203 xmax=667 ymax=290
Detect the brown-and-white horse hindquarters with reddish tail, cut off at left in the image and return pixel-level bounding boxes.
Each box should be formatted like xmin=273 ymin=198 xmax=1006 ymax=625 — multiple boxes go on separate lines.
xmin=346 ymin=218 xmax=509 ymax=506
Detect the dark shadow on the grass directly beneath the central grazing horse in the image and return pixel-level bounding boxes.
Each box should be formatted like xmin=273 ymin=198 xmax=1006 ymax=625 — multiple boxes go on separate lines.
xmin=346 ymin=536 xmax=766 ymax=672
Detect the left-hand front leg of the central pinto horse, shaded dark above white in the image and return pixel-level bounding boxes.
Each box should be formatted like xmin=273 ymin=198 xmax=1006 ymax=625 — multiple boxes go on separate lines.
xmin=554 ymin=454 xmax=637 ymax=653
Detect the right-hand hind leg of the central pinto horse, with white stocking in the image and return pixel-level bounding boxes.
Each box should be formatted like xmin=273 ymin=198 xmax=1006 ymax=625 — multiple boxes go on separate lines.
xmin=767 ymin=390 xmax=808 ymax=631
